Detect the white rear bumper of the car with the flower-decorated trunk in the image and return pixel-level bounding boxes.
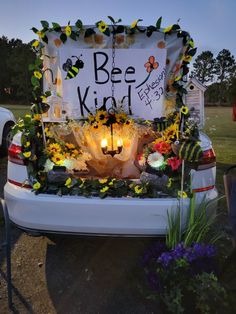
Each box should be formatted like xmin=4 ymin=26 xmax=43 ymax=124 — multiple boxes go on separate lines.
xmin=4 ymin=182 xmax=217 ymax=236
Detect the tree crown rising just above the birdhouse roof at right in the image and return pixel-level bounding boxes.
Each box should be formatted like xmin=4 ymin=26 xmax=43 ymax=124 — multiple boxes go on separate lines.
xmin=191 ymin=51 xmax=215 ymax=84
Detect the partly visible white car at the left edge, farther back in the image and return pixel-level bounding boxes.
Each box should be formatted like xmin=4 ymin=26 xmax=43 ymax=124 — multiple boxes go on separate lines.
xmin=0 ymin=107 xmax=15 ymax=156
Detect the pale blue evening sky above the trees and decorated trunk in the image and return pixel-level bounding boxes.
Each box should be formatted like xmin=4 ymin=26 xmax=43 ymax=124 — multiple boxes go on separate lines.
xmin=0 ymin=0 xmax=236 ymax=57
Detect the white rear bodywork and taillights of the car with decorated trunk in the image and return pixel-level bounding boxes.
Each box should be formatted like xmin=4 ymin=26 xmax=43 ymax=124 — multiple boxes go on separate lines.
xmin=4 ymin=133 xmax=217 ymax=236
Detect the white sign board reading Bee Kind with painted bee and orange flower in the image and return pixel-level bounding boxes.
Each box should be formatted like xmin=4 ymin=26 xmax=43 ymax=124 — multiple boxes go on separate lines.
xmin=59 ymin=47 xmax=166 ymax=120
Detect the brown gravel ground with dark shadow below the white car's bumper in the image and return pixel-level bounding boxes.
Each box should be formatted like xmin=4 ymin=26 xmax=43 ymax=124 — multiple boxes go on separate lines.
xmin=0 ymin=160 xmax=161 ymax=314
